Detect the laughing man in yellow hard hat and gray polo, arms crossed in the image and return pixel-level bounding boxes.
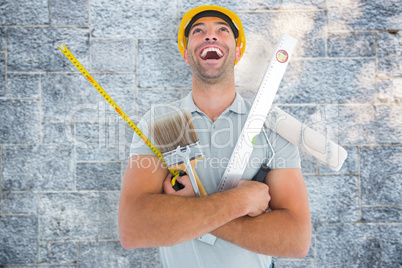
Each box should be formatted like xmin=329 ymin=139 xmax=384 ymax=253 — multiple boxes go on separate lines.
xmin=119 ymin=6 xmax=311 ymax=267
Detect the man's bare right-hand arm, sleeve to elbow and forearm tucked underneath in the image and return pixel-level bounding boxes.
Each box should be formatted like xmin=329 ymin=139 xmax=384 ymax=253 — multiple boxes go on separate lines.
xmin=212 ymin=168 xmax=311 ymax=258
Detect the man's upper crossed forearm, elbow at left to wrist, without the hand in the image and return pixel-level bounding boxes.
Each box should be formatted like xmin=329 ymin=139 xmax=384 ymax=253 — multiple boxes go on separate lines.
xmin=119 ymin=188 xmax=247 ymax=248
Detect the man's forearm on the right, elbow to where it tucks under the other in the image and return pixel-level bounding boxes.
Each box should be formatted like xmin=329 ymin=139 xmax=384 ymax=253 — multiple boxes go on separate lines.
xmin=211 ymin=210 xmax=311 ymax=258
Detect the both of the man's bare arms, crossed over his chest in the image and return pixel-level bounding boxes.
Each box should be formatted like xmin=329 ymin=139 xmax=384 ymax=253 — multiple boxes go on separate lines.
xmin=118 ymin=155 xmax=311 ymax=258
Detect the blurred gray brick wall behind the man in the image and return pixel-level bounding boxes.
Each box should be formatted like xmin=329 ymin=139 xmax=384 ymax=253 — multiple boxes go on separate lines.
xmin=0 ymin=0 xmax=402 ymax=268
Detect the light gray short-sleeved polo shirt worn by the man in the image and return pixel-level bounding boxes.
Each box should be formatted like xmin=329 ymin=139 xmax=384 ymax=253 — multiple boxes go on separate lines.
xmin=130 ymin=92 xmax=300 ymax=268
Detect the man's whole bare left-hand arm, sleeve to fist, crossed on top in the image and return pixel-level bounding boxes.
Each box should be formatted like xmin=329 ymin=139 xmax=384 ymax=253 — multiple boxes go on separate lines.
xmin=119 ymin=156 xmax=270 ymax=249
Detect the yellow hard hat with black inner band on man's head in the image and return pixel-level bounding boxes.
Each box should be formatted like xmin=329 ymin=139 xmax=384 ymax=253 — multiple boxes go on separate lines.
xmin=177 ymin=5 xmax=246 ymax=65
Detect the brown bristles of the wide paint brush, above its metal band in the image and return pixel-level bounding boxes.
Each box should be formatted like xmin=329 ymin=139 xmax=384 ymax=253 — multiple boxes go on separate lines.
xmin=149 ymin=109 xmax=198 ymax=153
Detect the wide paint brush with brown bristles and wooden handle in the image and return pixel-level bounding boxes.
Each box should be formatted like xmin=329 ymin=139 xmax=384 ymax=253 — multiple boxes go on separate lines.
xmin=149 ymin=109 xmax=207 ymax=196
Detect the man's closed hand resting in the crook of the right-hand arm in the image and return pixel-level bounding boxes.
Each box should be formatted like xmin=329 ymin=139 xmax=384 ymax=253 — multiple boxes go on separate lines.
xmin=237 ymin=180 xmax=271 ymax=217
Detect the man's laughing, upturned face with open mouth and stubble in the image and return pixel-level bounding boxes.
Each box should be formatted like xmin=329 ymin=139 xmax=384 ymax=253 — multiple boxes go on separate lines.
xmin=184 ymin=17 xmax=241 ymax=79
